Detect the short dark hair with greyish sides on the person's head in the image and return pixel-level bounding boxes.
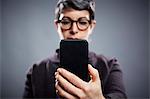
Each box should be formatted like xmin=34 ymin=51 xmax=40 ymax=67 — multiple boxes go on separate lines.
xmin=55 ymin=0 xmax=95 ymax=20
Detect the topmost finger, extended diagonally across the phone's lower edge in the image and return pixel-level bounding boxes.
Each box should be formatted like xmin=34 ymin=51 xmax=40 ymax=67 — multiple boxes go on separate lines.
xmin=57 ymin=68 xmax=87 ymax=89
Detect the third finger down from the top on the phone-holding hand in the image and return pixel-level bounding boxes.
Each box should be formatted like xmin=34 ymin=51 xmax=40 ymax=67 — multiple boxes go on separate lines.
xmin=55 ymin=84 xmax=76 ymax=99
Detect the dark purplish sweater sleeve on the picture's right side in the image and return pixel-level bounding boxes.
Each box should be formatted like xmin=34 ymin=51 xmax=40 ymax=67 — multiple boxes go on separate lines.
xmin=104 ymin=58 xmax=127 ymax=99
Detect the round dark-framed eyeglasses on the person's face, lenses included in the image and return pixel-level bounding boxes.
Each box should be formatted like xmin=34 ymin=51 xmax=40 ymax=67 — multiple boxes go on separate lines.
xmin=58 ymin=17 xmax=91 ymax=31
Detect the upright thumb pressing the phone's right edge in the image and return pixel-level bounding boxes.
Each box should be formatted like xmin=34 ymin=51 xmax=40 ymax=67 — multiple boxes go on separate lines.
xmin=88 ymin=64 xmax=99 ymax=82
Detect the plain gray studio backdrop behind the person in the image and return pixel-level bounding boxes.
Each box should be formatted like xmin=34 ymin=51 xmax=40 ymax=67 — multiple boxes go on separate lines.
xmin=0 ymin=0 xmax=149 ymax=99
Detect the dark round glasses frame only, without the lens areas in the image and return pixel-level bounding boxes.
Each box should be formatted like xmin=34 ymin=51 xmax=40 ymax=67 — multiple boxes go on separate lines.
xmin=57 ymin=17 xmax=91 ymax=31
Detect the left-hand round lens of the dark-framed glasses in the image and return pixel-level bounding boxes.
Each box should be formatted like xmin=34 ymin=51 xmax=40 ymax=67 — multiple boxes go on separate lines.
xmin=60 ymin=18 xmax=71 ymax=29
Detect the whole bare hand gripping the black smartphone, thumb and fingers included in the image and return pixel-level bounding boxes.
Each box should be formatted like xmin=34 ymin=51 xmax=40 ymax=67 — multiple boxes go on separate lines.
xmin=55 ymin=64 xmax=104 ymax=99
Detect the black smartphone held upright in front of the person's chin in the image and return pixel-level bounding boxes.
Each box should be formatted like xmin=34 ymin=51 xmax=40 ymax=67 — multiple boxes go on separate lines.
xmin=60 ymin=39 xmax=89 ymax=81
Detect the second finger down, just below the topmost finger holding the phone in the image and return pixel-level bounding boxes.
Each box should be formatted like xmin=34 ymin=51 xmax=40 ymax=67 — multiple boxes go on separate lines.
xmin=55 ymin=74 xmax=83 ymax=97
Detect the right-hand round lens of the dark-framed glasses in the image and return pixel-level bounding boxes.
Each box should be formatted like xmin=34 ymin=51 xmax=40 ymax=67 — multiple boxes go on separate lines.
xmin=77 ymin=18 xmax=90 ymax=30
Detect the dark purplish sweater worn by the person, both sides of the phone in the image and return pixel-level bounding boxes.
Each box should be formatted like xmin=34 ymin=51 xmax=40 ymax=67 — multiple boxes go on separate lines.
xmin=23 ymin=50 xmax=126 ymax=99
